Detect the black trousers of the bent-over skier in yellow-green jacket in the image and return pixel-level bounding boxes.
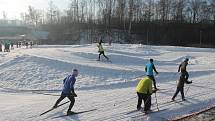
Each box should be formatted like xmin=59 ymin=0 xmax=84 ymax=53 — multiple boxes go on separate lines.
xmin=137 ymin=92 xmax=151 ymax=111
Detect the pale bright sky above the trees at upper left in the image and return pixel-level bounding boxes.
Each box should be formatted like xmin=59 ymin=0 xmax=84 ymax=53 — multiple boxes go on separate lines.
xmin=0 ymin=0 xmax=70 ymax=19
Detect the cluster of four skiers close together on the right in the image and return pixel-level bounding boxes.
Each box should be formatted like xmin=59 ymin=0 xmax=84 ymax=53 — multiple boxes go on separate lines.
xmin=136 ymin=58 xmax=192 ymax=113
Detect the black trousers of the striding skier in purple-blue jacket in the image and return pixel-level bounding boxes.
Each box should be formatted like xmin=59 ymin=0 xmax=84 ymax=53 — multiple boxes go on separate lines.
xmin=55 ymin=92 xmax=75 ymax=111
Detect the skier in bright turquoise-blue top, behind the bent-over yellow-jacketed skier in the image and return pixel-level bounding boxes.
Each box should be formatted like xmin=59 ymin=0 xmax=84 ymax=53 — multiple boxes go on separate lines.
xmin=145 ymin=59 xmax=158 ymax=90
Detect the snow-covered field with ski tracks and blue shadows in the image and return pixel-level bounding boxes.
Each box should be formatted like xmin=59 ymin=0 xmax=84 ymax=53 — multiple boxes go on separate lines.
xmin=0 ymin=44 xmax=215 ymax=121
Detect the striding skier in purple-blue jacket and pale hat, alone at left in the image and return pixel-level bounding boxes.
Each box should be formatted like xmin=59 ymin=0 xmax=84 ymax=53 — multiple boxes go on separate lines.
xmin=53 ymin=69 xmax=78 ymax=115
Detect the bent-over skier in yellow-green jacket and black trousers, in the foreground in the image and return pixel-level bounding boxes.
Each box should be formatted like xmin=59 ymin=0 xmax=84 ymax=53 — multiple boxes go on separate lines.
xmin=136 ymin=76 xmax=156 ymax=113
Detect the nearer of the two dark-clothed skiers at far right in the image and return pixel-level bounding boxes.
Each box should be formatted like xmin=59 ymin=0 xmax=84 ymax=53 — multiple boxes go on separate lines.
xmin=172 ymin=71 xmax=192 ymax=101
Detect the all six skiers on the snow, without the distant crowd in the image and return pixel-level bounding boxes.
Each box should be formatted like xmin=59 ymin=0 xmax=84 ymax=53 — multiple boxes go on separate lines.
xmin=53 ymin=42 xmax=192 ymax=115
